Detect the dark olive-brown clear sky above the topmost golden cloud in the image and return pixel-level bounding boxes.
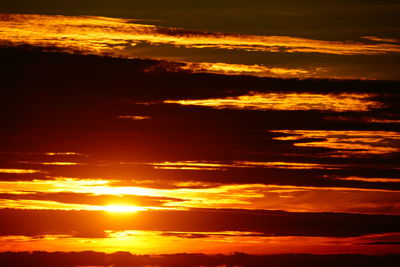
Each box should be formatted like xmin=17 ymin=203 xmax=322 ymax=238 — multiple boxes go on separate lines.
xmin=0 ymin=0 xmax=400 ymax=40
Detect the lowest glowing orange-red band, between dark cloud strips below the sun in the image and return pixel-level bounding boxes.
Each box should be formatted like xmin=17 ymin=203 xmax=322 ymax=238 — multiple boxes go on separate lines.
xmin=0 ymin=230 xmax=399 ymax=255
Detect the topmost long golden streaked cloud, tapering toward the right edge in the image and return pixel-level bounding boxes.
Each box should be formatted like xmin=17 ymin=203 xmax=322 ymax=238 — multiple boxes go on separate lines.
xmin=0 ymin=14 xmax=400 ymax=58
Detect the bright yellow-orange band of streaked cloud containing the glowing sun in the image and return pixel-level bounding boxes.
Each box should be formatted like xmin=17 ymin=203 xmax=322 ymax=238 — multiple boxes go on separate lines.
xmin=0 ymin=179 xmax=400 ymax=215
